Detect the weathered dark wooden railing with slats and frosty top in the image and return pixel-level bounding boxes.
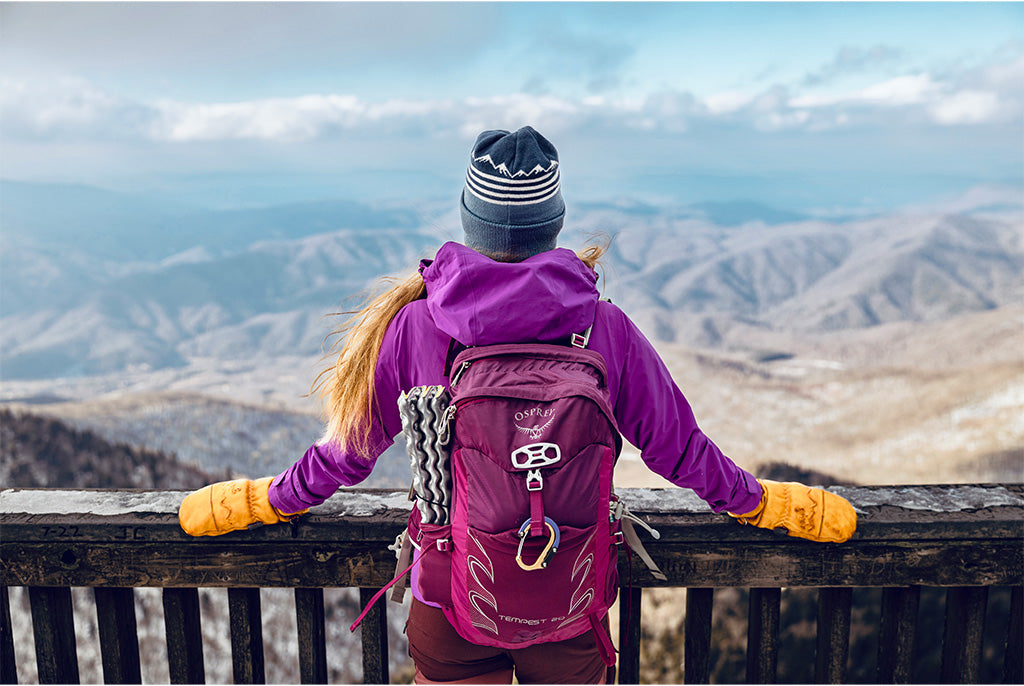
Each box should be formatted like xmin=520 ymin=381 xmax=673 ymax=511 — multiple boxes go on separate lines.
xmin=0 ymin=484 xmax=1024 ymax=683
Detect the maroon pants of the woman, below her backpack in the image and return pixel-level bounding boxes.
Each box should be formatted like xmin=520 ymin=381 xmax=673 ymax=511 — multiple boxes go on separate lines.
xmin=406 ymin=598 xmax=615 ymax=684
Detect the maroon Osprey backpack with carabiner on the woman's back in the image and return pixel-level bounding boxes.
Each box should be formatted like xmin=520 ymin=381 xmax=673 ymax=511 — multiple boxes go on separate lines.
xmin=409 ymin=336 xmax=622 ymax=664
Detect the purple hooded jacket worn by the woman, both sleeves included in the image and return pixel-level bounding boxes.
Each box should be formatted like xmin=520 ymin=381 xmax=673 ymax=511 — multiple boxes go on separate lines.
xmin=269 ymin=243 xmax=761 ymax=513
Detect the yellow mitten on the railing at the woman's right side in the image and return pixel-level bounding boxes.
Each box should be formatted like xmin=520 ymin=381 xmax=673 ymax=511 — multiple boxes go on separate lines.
xmin=730 ymin=479 xmax=857 ymax=543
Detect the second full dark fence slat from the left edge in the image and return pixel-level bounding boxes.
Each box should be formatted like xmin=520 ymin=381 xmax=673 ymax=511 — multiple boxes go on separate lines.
xmin=93 ymin=586 xmax=142 ymax=684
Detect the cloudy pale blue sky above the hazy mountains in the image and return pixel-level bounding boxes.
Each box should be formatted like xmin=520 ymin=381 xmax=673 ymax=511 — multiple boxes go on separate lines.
xmin=0 ymin=2 xmax=1024 ymax=211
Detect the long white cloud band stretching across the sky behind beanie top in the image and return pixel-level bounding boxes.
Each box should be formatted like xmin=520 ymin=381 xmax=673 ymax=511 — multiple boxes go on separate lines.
xmin=0 ymin=43 xmax=1024 ymax=151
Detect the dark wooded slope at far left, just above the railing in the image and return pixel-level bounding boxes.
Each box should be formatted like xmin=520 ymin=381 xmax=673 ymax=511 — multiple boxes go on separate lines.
xmin=0 ymin=409 xmax=218 ymax=489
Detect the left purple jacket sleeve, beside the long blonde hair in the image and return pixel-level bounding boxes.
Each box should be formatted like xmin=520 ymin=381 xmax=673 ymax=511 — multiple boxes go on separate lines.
xmin=269 ymin=300 xmax=450 ymax=513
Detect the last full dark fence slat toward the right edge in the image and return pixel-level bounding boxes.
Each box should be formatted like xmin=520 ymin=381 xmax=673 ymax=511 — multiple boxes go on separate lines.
xmin=941 ymin=586 xmax=988 ymax=684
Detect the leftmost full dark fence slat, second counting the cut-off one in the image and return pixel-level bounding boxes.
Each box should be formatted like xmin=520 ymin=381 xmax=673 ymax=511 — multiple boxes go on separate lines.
xmin=29 ymin=586 xmax=79 ymax=684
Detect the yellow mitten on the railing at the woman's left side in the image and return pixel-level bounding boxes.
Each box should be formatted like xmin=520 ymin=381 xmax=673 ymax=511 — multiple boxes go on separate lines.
xmin=178 ymin=476 xmax=307 ymax=535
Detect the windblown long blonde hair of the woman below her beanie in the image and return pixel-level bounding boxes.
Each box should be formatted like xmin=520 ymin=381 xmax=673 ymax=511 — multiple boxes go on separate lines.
xmin=312 ymin=240 xmax=610 ymax=460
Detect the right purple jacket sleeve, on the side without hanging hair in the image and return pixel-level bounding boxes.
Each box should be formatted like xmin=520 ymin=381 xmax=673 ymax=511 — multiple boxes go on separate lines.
xmin=595 ymin=303 xmax=761 ymax=513
